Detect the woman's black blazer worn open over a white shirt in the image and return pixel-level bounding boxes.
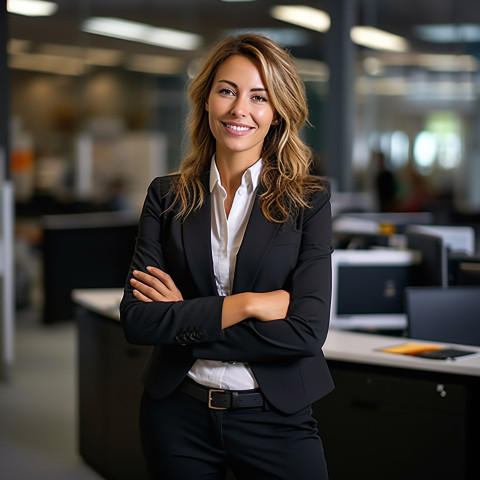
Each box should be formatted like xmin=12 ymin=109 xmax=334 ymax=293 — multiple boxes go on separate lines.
xmin=120 ymin=171 xmax=333 ymax=413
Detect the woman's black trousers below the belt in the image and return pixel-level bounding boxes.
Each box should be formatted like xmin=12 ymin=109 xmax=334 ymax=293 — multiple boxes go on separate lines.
xmin=140 ymin=391 xmax=328 ymax=480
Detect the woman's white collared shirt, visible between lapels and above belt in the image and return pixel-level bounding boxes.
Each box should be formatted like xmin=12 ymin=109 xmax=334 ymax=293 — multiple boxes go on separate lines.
xmin=189 ymin=156 xmax=262 ymax=390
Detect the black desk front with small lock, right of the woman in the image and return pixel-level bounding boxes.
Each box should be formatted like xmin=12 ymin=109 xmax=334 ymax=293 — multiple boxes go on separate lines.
xmin=314 ymin=362 xmax=479 ymax=480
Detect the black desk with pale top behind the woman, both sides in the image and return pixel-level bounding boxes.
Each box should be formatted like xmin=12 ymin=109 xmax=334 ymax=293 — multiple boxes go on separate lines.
xmin=73 ymin=289 xmax=480 ymax=480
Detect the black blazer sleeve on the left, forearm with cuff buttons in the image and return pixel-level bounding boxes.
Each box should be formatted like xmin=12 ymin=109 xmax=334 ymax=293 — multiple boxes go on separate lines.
xmin=120 ymin=177 xmax=224 ymax=346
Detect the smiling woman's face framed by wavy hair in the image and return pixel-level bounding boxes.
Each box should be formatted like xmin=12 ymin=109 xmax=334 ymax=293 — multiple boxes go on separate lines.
xmin=206 ymin=55 xmax=275 ymax=164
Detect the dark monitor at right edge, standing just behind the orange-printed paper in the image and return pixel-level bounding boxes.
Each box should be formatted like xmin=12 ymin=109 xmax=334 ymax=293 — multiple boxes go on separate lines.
xmin=405 ymin=287 xmax=480 ymax=346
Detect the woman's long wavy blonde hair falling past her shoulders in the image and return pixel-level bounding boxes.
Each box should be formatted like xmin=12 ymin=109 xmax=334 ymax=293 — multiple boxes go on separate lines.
xmin=172 ymin=33 xmax=322 ymax=223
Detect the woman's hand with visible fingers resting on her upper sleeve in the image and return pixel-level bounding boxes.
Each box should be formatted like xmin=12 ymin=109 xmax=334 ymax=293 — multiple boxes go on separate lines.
xmin=130 ymin=267 xmax=183 ymax=302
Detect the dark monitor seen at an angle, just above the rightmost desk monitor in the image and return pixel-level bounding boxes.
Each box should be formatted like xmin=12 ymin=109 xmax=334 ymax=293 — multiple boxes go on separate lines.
xmin=405 ymin=229 xmax=448 ymax=287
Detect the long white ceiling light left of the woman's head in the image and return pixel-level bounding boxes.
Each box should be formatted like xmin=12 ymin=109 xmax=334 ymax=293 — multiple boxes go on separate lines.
xmin=82 ymin=17 xmax=201 ymax=50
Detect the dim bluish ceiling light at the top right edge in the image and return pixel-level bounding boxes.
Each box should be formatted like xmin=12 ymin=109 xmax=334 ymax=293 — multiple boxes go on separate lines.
xmin=414 ymin=23 xmax=480 ymax=43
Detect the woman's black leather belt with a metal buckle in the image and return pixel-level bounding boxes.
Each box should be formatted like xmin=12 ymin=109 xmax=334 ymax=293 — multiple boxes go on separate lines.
xmin=179 ymin=378 xmax=265 ymax=410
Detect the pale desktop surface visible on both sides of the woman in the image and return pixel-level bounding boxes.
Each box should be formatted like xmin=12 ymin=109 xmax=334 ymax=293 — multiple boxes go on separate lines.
xmin=73 ymin=288 xmax=480 ymax=377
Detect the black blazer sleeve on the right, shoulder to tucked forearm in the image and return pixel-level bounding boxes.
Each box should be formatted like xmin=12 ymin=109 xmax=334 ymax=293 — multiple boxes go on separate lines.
xmin=193 ymin=188 xmax=332 ymax=362
